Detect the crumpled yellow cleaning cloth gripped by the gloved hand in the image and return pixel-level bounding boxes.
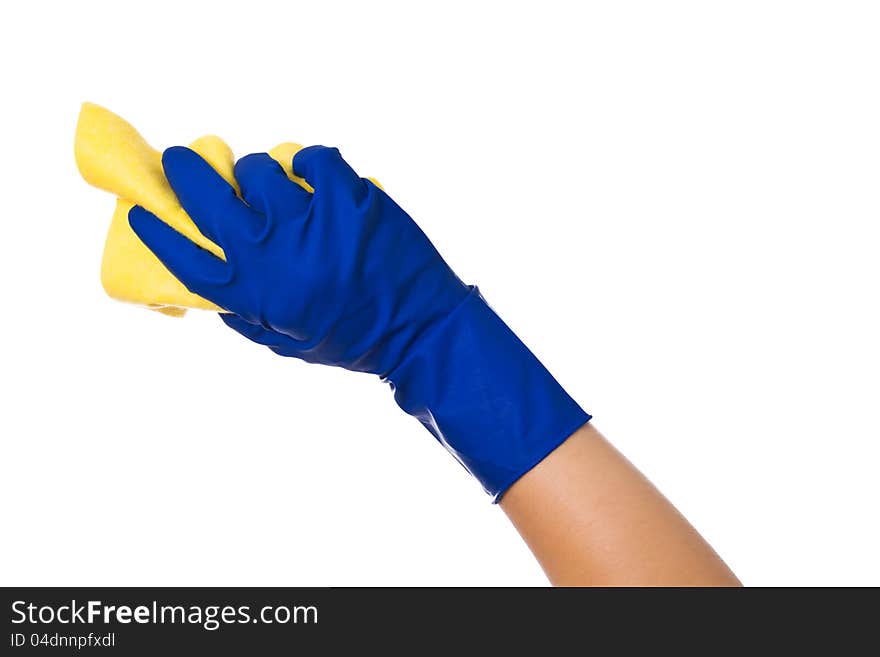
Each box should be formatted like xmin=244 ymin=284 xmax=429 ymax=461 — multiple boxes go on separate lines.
xmin=74 ymin=103 xmax=312 ymax=317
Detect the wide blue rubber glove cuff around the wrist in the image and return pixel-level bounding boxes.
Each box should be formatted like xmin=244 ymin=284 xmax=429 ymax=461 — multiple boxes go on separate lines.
xmin=385 ymin=287 xmax=591 ymax=502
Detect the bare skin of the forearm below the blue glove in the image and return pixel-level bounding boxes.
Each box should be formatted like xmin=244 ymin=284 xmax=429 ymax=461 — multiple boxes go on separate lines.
xmin=500 ymin=423 xmax=741 ymax=586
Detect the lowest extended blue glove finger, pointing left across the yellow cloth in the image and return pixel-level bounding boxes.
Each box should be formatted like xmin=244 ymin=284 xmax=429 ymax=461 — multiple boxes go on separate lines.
xmin=128 ymin=205 xmax=231 ymax=308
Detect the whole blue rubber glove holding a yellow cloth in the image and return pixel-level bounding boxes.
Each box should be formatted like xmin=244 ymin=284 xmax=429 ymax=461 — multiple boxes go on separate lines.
xmin=129 ymin=146 xmax=590 ymax=501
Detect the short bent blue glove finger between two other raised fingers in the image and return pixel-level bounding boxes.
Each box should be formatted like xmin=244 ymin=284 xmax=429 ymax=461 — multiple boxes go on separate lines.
xmin=235 ymin=153 xmax=312 ymax=215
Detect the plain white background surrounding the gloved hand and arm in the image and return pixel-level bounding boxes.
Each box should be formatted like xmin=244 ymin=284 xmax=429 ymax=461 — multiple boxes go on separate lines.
xmin=0 ymin=0 xmax=880 ymax=585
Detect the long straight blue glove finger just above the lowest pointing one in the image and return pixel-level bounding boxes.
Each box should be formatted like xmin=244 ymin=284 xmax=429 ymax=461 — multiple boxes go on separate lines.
xmin=162 ymin=146 xmax=263 ymax=247
